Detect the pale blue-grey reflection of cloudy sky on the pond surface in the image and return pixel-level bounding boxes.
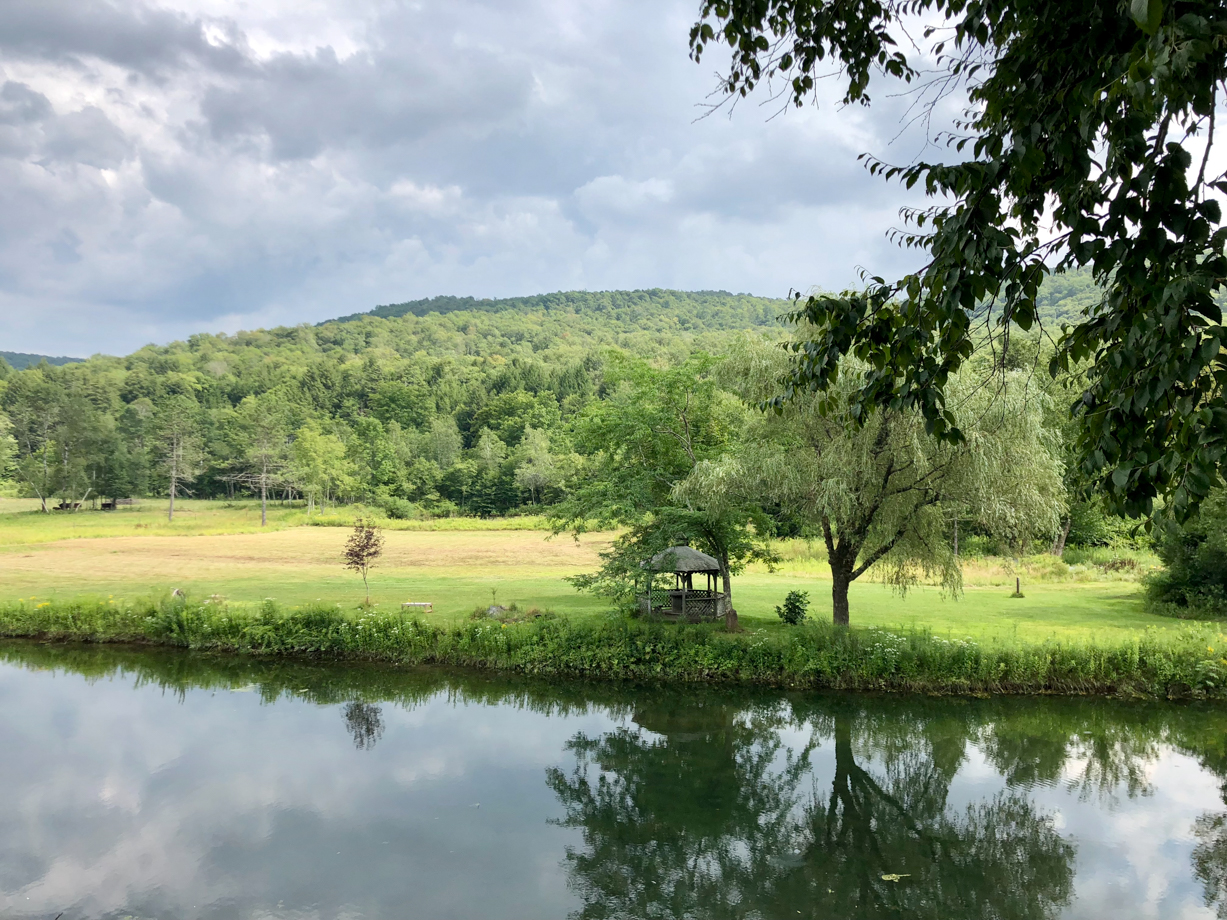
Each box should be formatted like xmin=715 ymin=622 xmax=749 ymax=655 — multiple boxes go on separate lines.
xmin=0 ymin=665 xmax=1223 ymax=920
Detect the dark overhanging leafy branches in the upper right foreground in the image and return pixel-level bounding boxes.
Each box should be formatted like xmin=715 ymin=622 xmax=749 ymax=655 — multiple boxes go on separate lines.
xmin=691 ymin=0 xmax=1227 ymax=518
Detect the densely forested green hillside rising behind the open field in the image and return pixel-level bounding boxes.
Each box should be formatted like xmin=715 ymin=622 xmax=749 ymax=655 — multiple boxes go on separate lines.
xmin=0 ymin=282 xmax=1114 ymax=525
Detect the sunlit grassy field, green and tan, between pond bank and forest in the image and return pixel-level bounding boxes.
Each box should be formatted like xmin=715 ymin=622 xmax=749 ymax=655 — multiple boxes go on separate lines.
xmin=0 ymin=499 xmax=1180 ymax=640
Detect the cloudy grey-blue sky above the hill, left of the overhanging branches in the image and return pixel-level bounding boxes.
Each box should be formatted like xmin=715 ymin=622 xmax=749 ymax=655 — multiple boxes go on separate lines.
xmin=0 ymin=0 xmax=924 ymax=356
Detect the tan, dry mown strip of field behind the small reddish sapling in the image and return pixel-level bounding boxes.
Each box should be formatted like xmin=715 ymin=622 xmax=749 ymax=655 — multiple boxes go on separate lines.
xmin=0 ymin=527 xmax=606 ymax=617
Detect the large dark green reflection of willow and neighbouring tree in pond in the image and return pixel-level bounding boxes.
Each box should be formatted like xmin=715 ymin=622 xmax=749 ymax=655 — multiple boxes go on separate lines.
xmin=548 ymin=700 xmax=1074 ymax=920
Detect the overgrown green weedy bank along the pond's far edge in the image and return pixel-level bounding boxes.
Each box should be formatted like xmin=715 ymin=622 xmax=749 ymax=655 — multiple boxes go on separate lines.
xmin=0 ymin=599 xmax=1227 ymax=698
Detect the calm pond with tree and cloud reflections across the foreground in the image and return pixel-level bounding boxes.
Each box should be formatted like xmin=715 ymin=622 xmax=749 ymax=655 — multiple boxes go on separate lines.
xmin=0 ymin=643 xmax=1227 ymax=920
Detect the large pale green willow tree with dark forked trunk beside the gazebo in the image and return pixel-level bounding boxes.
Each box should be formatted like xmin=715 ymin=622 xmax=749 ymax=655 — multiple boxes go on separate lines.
xmin=680 ymin=341 xmax=1065 ymax=626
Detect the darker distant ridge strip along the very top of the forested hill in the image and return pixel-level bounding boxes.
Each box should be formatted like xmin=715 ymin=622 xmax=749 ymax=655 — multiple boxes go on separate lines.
xmin=336 ymin=288 xmax=789 ymax=332
